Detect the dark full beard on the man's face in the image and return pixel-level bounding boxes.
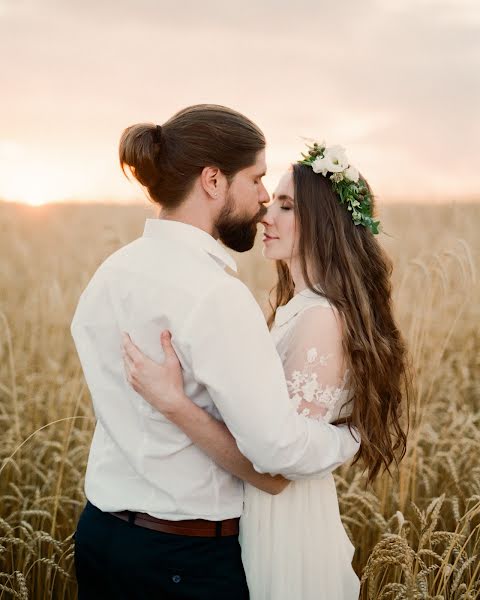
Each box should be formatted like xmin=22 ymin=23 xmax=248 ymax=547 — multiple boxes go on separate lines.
xmin=216 ymin=189 xmax=267 ymax=252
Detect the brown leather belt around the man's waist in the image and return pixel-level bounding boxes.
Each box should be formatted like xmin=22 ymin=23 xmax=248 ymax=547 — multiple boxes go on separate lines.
xmin=110 ymin=510 xmax=240 ymax=537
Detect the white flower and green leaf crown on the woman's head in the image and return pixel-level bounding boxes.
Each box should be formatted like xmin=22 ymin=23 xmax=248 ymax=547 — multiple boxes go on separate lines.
xmin=298 ymin=142 xmax=380 ymax=234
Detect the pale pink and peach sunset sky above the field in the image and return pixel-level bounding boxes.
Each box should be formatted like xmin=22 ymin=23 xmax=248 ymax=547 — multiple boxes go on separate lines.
xmin=0 ymin=0 xmax=480 ymax=204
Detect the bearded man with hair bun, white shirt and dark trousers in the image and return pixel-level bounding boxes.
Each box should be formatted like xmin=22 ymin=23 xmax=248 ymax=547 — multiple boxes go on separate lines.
xmin=72 ymin=105 xmax=358 ymax=600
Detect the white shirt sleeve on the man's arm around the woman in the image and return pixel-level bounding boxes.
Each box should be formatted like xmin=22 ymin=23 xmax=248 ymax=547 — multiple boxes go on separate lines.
xmin=180 ymin=278 xmax=359 ymax=479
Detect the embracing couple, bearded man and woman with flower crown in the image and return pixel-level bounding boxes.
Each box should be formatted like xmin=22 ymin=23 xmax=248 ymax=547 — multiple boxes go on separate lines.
xmin=72 ymin=105 xmax=407 ymax=600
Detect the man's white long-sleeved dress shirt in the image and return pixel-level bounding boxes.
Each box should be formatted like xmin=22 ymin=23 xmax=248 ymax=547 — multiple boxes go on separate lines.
xmin=71 ymin=219 xmax=358 ymax=520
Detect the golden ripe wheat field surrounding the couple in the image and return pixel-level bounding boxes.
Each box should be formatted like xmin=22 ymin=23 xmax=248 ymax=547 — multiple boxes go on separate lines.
xmin=0 ymin=204 xmax=480 ymax=600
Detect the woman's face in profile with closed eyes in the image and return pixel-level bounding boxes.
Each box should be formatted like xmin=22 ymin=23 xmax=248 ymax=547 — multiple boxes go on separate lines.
xmin=261 ymin=171 xmax=298 ymax=261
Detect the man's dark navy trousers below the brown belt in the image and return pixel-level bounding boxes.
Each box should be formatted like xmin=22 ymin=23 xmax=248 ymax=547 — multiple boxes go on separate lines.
xmin=75 ymin=502 xmax=249 ymax=600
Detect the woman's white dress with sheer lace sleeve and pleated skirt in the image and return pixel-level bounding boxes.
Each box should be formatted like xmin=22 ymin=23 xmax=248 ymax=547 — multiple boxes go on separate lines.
xmin=240 ymin=290 xmax=360 ymax=600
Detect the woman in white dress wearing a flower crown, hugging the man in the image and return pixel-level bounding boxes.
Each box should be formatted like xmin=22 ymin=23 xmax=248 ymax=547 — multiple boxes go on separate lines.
xmin=124 ymin=144 xmax=407 ymax=600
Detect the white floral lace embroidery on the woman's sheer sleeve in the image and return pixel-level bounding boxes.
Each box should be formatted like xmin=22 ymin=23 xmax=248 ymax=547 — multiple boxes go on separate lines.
xmin=287 ymin=348 xmax=345 ymax=421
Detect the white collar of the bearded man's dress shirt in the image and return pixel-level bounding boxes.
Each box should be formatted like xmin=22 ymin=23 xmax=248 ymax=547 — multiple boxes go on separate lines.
xmin=143 ymin=219 xmax=237 ymax=272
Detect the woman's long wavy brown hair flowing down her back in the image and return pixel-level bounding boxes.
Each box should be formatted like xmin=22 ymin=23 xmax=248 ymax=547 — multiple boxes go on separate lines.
xmin=269 ymin=164 xmax=410 ymax=482
